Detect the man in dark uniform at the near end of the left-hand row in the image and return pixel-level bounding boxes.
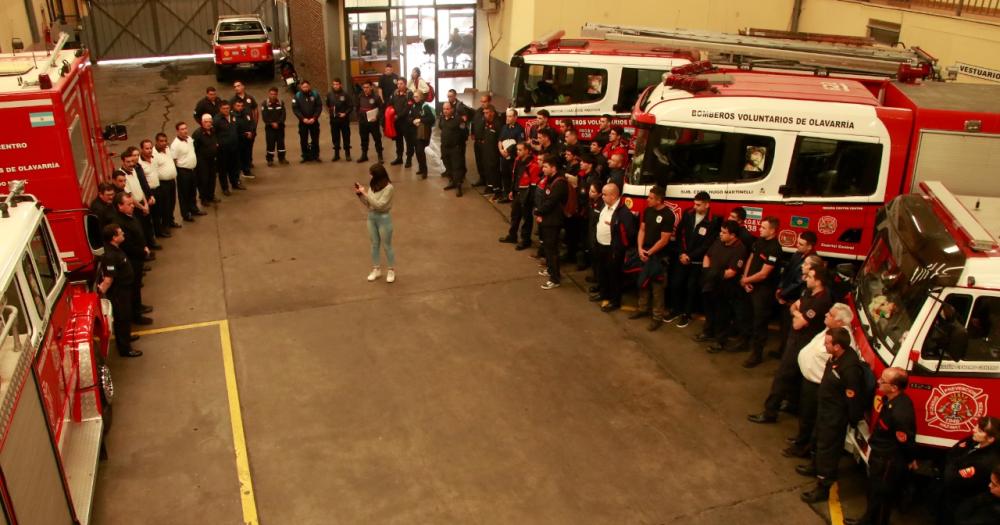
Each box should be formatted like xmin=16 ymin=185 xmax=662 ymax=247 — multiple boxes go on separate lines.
xmin=97 ymin=224 xmax=142 ymax=357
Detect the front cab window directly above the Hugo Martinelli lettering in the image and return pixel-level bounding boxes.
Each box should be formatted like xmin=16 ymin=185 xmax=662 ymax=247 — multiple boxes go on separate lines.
xmin=629 ymin=126 xmax=774 ymax=186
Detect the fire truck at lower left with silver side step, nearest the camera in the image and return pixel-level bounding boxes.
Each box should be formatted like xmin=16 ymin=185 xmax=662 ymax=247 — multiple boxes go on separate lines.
xmin=0 ymin=182 xmax=113 ymax=525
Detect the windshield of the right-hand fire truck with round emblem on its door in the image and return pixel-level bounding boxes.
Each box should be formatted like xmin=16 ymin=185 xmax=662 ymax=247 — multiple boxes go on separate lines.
xmin=856 ymin=195 xmax=965 ymax=353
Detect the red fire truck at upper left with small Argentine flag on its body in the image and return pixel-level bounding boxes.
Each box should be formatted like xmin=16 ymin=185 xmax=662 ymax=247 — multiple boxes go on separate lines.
xmin=0 ymin=34 xmax=126 ymax=271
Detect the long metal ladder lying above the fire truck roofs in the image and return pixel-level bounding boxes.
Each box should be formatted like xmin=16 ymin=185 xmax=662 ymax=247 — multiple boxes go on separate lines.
xmin=581 ymin=23 xmax=940 ymax=80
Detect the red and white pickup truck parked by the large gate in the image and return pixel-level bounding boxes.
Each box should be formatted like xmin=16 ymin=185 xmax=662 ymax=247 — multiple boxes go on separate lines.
xmin=208 ymin=14 xmax=274 ymax=81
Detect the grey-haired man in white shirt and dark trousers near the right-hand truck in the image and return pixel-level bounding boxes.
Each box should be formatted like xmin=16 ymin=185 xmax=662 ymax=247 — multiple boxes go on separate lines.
xmin=782 ymin=303 xmax=858 ymax=457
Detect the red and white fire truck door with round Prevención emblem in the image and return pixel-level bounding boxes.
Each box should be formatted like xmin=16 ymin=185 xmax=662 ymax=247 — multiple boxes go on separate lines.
xmin=907 ymin=288 xmax=1000 ymax=446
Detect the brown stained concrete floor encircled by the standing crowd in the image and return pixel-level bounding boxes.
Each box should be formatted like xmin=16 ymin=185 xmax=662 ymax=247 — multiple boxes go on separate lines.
xmin=86 ymin=63 xmax=916 ymax=524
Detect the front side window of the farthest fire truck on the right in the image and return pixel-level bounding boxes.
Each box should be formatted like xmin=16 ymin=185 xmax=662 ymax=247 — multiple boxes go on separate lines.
xmin=514 ymin=64 xmax=608 ymax=107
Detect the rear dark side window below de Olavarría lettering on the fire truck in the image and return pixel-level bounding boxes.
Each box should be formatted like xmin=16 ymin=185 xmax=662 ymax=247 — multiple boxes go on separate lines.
xmin=786 ymin=136 xmax=882 ymax=197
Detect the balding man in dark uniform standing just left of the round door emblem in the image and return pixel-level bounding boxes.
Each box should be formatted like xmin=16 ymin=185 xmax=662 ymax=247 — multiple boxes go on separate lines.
xmin=844 ymin=367 xmax=917 ymax=525
